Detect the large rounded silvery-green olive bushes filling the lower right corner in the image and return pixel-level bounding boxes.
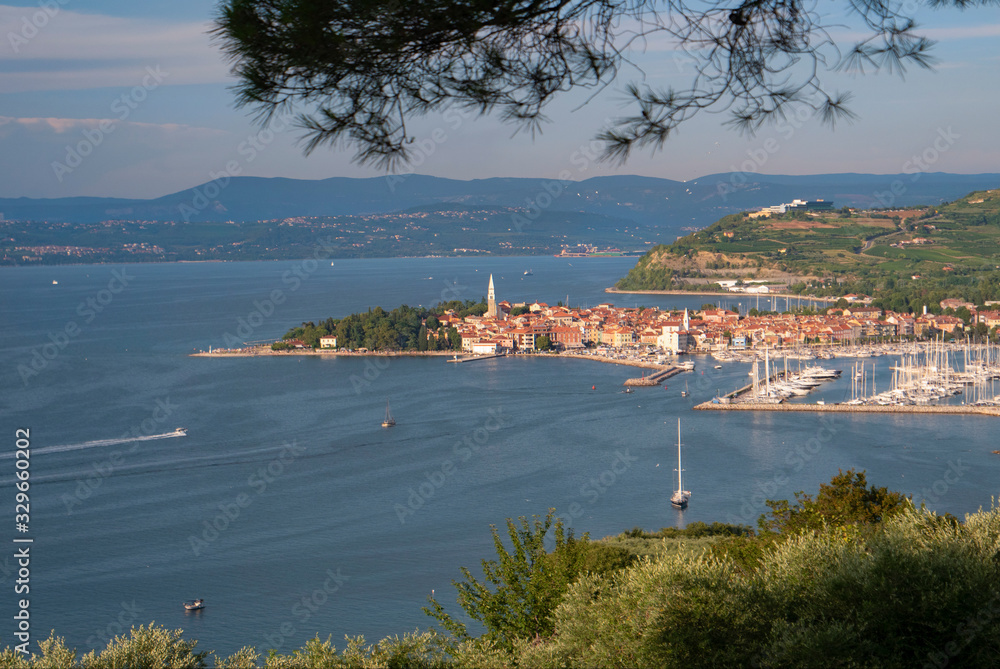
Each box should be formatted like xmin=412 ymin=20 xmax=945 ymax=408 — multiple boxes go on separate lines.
xmin=516 ymin=509 xmax=1000 ymax=667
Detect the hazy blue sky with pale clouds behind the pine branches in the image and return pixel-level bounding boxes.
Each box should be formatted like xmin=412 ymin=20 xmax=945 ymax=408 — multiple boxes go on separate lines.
xmin=0 ymin=0 xmax=1000 ymax=197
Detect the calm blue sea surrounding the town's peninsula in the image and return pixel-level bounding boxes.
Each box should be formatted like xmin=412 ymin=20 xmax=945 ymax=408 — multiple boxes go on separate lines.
xmin=0 ymin=258 xmax=1000 ymax=654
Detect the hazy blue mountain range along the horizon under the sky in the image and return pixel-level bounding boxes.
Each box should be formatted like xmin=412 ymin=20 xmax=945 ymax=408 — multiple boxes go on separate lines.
xmin=0 ymin=172 xmax=1000 ymax=230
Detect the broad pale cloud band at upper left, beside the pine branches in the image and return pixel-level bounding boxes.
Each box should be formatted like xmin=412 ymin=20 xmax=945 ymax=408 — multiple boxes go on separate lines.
xmin=0 ymin=3 xmax=228 ymax=92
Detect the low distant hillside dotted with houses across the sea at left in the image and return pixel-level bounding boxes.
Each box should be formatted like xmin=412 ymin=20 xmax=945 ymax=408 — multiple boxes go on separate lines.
xmin=0 ymin=204 xmax=672 ymax=265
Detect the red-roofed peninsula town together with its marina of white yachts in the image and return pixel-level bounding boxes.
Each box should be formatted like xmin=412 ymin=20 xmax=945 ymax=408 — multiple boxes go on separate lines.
xmin=203 ymin=276 xmax=1000 ymax=415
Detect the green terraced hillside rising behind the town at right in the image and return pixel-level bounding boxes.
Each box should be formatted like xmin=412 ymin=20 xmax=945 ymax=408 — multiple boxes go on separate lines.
xmin=616 ymin=190 xmax=1000 ymax=308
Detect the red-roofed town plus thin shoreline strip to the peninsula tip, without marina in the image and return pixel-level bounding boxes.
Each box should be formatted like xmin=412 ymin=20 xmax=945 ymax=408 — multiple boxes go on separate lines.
xmin=212 ymin=276 xmax=1000 ymax=362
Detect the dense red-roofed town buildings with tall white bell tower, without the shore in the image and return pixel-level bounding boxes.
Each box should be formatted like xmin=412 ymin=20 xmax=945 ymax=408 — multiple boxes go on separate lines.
xmin=370 ymin=276 xmax=1000 ymax=355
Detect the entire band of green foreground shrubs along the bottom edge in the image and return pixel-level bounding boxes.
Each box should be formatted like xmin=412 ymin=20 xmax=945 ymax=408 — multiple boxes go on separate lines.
xmin=0 ymin=472 xmax=1000 ymax=669
